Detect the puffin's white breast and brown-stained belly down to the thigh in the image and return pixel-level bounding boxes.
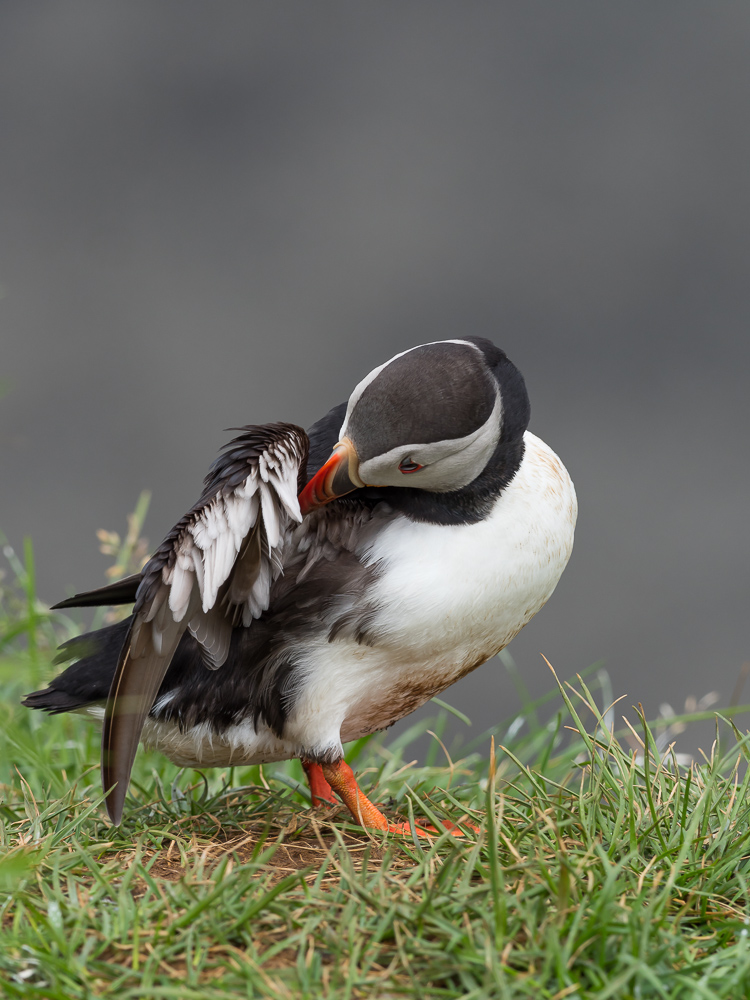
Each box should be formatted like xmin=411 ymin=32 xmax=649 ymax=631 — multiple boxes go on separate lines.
xmin=285 ymin=432 xmax=577 ymax=749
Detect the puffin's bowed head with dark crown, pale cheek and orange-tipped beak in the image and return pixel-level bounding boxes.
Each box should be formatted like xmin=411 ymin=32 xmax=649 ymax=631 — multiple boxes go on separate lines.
xmin=299 ymin=338 xmax=529 ymax=514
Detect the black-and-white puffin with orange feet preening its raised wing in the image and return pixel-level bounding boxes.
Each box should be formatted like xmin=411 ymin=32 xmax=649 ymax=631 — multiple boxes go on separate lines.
xmin=23 ymin=337 xmax=577 ymax=834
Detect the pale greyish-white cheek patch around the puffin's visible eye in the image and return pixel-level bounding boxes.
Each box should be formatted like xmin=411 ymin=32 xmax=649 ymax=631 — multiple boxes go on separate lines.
xmin=359 ymin=393 xmax=502 ymax=493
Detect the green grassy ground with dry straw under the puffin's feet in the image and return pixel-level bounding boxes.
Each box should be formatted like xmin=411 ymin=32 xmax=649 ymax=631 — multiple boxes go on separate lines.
xmin=0 ymin=546 xmax=750 ymax=1000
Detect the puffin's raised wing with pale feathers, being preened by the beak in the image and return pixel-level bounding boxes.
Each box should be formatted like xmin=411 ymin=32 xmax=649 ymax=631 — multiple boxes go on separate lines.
xmin=102 ymin=424 xmax=309 ymax=823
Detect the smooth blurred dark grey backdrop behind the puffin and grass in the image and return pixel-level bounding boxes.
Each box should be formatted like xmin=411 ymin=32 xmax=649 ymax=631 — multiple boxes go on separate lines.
xmin=0 ymin=0 xmax=750 ymax=756
